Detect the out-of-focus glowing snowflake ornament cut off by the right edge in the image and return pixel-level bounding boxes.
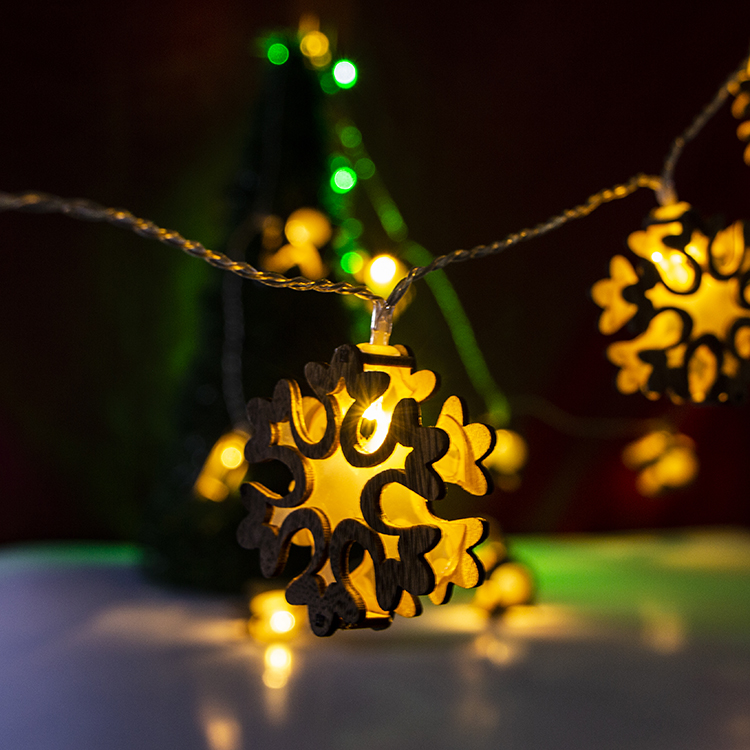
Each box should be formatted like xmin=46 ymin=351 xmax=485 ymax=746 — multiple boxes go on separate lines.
xmin=591 ymin=203 xmax=750 ymax=403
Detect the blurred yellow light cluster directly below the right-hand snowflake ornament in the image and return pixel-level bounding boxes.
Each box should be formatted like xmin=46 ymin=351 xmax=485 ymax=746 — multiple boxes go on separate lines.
xmin=622 ymin=430 xmax=699 ymax=497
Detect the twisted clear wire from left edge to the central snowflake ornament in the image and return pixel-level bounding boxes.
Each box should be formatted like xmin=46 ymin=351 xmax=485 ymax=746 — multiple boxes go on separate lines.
xmin=0 ymin=192 xmax=382 ymax=302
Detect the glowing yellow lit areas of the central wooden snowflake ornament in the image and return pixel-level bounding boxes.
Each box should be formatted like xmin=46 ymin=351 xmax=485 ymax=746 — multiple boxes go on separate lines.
xmin=267 ymin=344 xmax=491 ymax=619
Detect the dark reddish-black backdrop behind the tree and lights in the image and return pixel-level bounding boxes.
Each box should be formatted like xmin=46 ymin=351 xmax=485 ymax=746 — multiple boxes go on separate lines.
xmin=0 ymin=0 xmax=750 ymax=542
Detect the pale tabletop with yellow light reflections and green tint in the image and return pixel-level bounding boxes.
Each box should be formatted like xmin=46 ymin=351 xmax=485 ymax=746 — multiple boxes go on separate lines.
xmin=0 ymin=531 xmax=750 ymax=750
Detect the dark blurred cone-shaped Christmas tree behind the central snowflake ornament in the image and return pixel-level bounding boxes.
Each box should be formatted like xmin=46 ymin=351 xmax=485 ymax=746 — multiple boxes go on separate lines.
xmin=143 ymin=29 xmax=356 ymax=591
